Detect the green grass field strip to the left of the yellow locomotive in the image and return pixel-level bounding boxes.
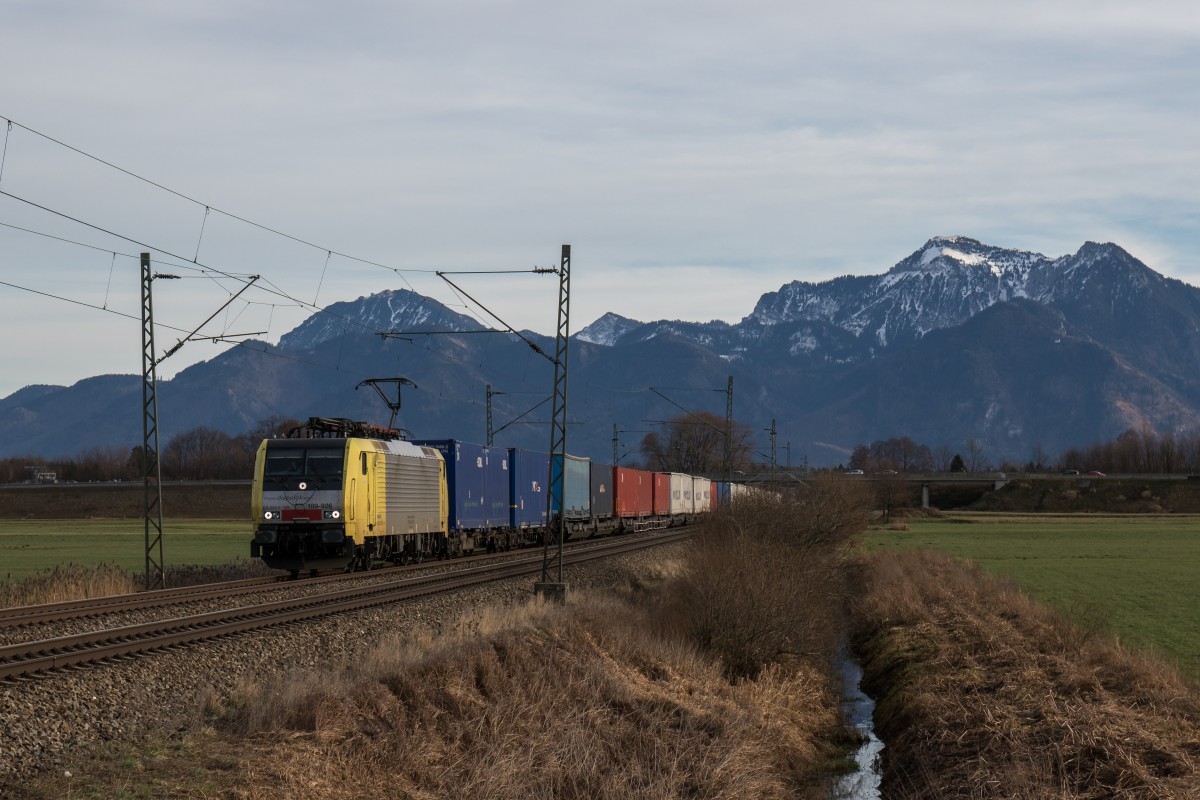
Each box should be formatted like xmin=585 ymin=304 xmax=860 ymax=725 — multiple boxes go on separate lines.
xmin=0 ymin=519 xmax=252 ymax=581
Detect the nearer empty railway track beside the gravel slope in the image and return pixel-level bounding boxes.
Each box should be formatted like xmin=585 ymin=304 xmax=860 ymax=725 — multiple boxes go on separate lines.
xmin=0 ymin=528 xmax=692 ymax=682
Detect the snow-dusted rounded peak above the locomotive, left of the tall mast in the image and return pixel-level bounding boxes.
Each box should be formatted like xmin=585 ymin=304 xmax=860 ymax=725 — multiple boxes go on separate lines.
xmin=280 ymin=289 xmax=482 ymax=350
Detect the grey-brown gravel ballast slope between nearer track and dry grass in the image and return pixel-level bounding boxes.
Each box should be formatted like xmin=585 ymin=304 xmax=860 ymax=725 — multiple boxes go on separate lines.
xmin=0 ymin=543 xmax=686 ymax=796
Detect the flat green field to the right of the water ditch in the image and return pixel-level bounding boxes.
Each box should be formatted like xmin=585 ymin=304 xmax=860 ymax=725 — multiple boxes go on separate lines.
xmin=865 ymin=515 xmax=1200 ymax=680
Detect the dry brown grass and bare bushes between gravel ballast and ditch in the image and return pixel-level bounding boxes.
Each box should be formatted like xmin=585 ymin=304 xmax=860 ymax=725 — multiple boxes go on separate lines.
xmin=11 ymin=494 xmax=865 ymax=800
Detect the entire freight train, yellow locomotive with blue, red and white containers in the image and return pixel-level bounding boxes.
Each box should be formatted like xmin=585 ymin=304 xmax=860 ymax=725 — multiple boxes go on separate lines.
xmin=251 ymin=417 xmax=746 ymax=577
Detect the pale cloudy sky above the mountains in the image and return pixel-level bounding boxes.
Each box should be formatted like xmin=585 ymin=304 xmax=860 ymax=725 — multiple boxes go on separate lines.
xmin=0 ymin=0 xmax=1200 ymax=398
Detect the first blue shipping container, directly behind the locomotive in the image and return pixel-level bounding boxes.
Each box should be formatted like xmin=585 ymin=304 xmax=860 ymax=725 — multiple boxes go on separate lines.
xmin=413 ymin=439 xmax=509 ymax=530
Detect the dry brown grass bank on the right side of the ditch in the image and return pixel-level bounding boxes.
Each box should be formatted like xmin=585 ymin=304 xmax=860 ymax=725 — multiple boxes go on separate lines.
xmin=857 ymin=551 xmax=1200 ymax=800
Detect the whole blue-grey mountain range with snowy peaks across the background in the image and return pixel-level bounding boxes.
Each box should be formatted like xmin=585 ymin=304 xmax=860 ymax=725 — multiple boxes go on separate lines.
xmin=0 ymin=236 xmax=1200 ymax=463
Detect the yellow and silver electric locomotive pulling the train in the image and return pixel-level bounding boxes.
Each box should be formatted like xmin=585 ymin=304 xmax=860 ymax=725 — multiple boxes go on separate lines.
xmin=251 ymin=417 xmax=448 ymax=577
